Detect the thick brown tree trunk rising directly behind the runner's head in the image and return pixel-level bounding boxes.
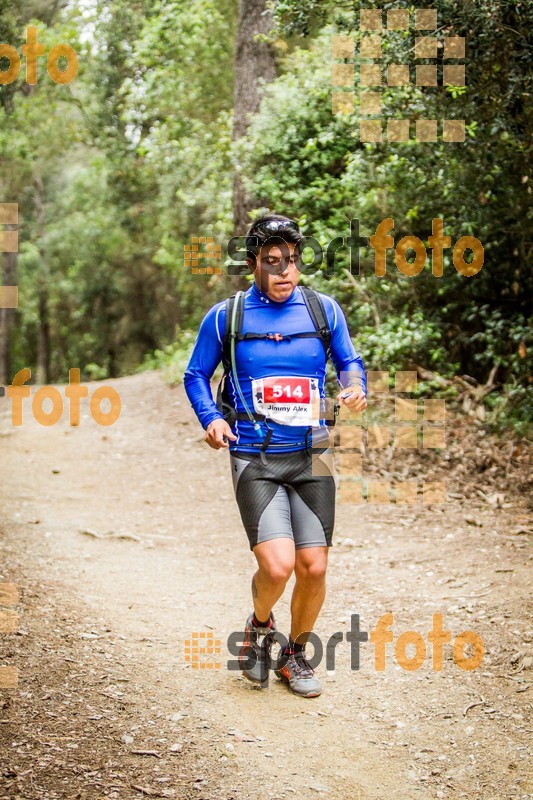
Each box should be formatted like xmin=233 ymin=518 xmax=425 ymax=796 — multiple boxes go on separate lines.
xmin=233 ymin=0 xmax=276 ymax=236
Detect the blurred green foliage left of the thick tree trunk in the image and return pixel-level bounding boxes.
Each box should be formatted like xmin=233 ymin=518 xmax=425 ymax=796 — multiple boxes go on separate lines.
xmin=0 ymin=0 xmax=236 ymax=380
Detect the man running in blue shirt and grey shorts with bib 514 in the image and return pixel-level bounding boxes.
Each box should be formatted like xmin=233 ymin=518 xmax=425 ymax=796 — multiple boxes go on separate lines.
xmin=184 ymin=214 xmax=366 ymax=697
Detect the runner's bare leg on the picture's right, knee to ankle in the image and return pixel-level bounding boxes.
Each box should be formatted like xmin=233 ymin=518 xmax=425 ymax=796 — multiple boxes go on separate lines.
xmin=291 ymin=547 xmax=329 ymax=644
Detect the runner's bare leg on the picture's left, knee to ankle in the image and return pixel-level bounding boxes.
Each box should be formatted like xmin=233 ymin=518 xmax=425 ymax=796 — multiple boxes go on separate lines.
xmin=252 ymin=537 xmax=296 ymax=622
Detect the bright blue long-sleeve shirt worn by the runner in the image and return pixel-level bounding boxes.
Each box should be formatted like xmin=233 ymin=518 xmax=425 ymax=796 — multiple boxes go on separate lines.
xmin=184 ymin=284 xmax=367 ymax=453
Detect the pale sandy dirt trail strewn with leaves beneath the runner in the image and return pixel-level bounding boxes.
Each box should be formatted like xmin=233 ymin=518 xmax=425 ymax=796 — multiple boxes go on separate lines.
xmin=0 ymin=373 xmax=533 ymax=800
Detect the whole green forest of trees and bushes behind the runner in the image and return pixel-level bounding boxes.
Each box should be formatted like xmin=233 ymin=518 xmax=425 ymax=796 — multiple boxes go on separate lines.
xmin=0 ymin=0 xmax=533 ymax=434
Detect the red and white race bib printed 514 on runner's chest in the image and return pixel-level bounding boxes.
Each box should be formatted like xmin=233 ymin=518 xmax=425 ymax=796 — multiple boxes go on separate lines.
xmin=252 ymin=376 xmax=320 ymax=426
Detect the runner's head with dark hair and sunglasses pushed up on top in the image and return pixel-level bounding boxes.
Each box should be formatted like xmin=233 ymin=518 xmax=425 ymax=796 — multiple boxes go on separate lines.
xmin=246 ymin=214 xmax=303 ymax=302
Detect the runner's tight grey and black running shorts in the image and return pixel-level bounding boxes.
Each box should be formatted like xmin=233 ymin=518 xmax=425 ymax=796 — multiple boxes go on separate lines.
xmin=230 ymin=448 xmax=335 ymax=550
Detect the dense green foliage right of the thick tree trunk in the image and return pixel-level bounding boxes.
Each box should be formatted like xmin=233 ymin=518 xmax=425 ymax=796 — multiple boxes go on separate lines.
xmin=240 ymin=2 xmax=533 ymax=432
